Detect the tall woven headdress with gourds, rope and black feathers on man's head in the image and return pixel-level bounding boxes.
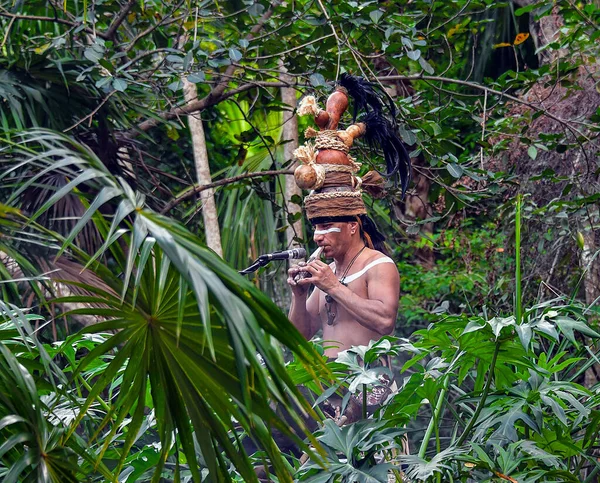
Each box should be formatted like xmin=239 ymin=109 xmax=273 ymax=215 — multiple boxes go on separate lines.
xmin=294 ymin=74 xmax=411 ymax=242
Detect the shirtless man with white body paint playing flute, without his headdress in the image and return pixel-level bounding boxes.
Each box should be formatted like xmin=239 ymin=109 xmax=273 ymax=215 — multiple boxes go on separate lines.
xmin=288 ymin=220 xmax=400 ymax=358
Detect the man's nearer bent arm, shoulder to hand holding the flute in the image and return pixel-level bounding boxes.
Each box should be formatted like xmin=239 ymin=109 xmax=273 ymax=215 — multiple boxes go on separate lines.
xmin=300 ymin=261 xmax=400 ymax=335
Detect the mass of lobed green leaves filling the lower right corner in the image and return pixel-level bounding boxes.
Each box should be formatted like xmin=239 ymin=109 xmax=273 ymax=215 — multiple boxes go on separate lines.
xmin=301 ymin=300 xmax=600 ymax=482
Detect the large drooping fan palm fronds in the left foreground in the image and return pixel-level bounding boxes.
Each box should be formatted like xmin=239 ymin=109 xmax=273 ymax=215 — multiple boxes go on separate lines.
xmin=0 ymin=130 xmax=326 ymax=481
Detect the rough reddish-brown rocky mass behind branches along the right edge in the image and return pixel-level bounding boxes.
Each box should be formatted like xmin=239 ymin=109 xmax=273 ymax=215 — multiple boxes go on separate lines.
xmin=486 ymin=0 xmax=600 ymax=304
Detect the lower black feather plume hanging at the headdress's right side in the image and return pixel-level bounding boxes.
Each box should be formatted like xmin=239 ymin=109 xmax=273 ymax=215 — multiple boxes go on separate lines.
xmin=361 ymin=111 xmax=411 ymax=197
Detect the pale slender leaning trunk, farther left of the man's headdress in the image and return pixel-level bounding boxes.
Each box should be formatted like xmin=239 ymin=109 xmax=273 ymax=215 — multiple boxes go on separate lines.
xmin=182 ymin=77 xmax=223 ymax=257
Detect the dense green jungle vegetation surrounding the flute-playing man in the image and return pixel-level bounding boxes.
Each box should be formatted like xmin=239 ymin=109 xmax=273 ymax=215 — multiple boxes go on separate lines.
xmin=0 ymin=0 xmax=600 ymax=483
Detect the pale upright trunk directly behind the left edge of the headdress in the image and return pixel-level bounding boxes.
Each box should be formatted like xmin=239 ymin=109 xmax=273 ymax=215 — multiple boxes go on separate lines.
xmin=279 ymin=62 xmax=302 ymax=263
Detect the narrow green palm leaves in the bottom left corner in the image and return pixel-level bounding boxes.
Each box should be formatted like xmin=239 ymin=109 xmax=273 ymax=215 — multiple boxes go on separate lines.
xmin=0 ymin=303 xmax=110 ymax=483
